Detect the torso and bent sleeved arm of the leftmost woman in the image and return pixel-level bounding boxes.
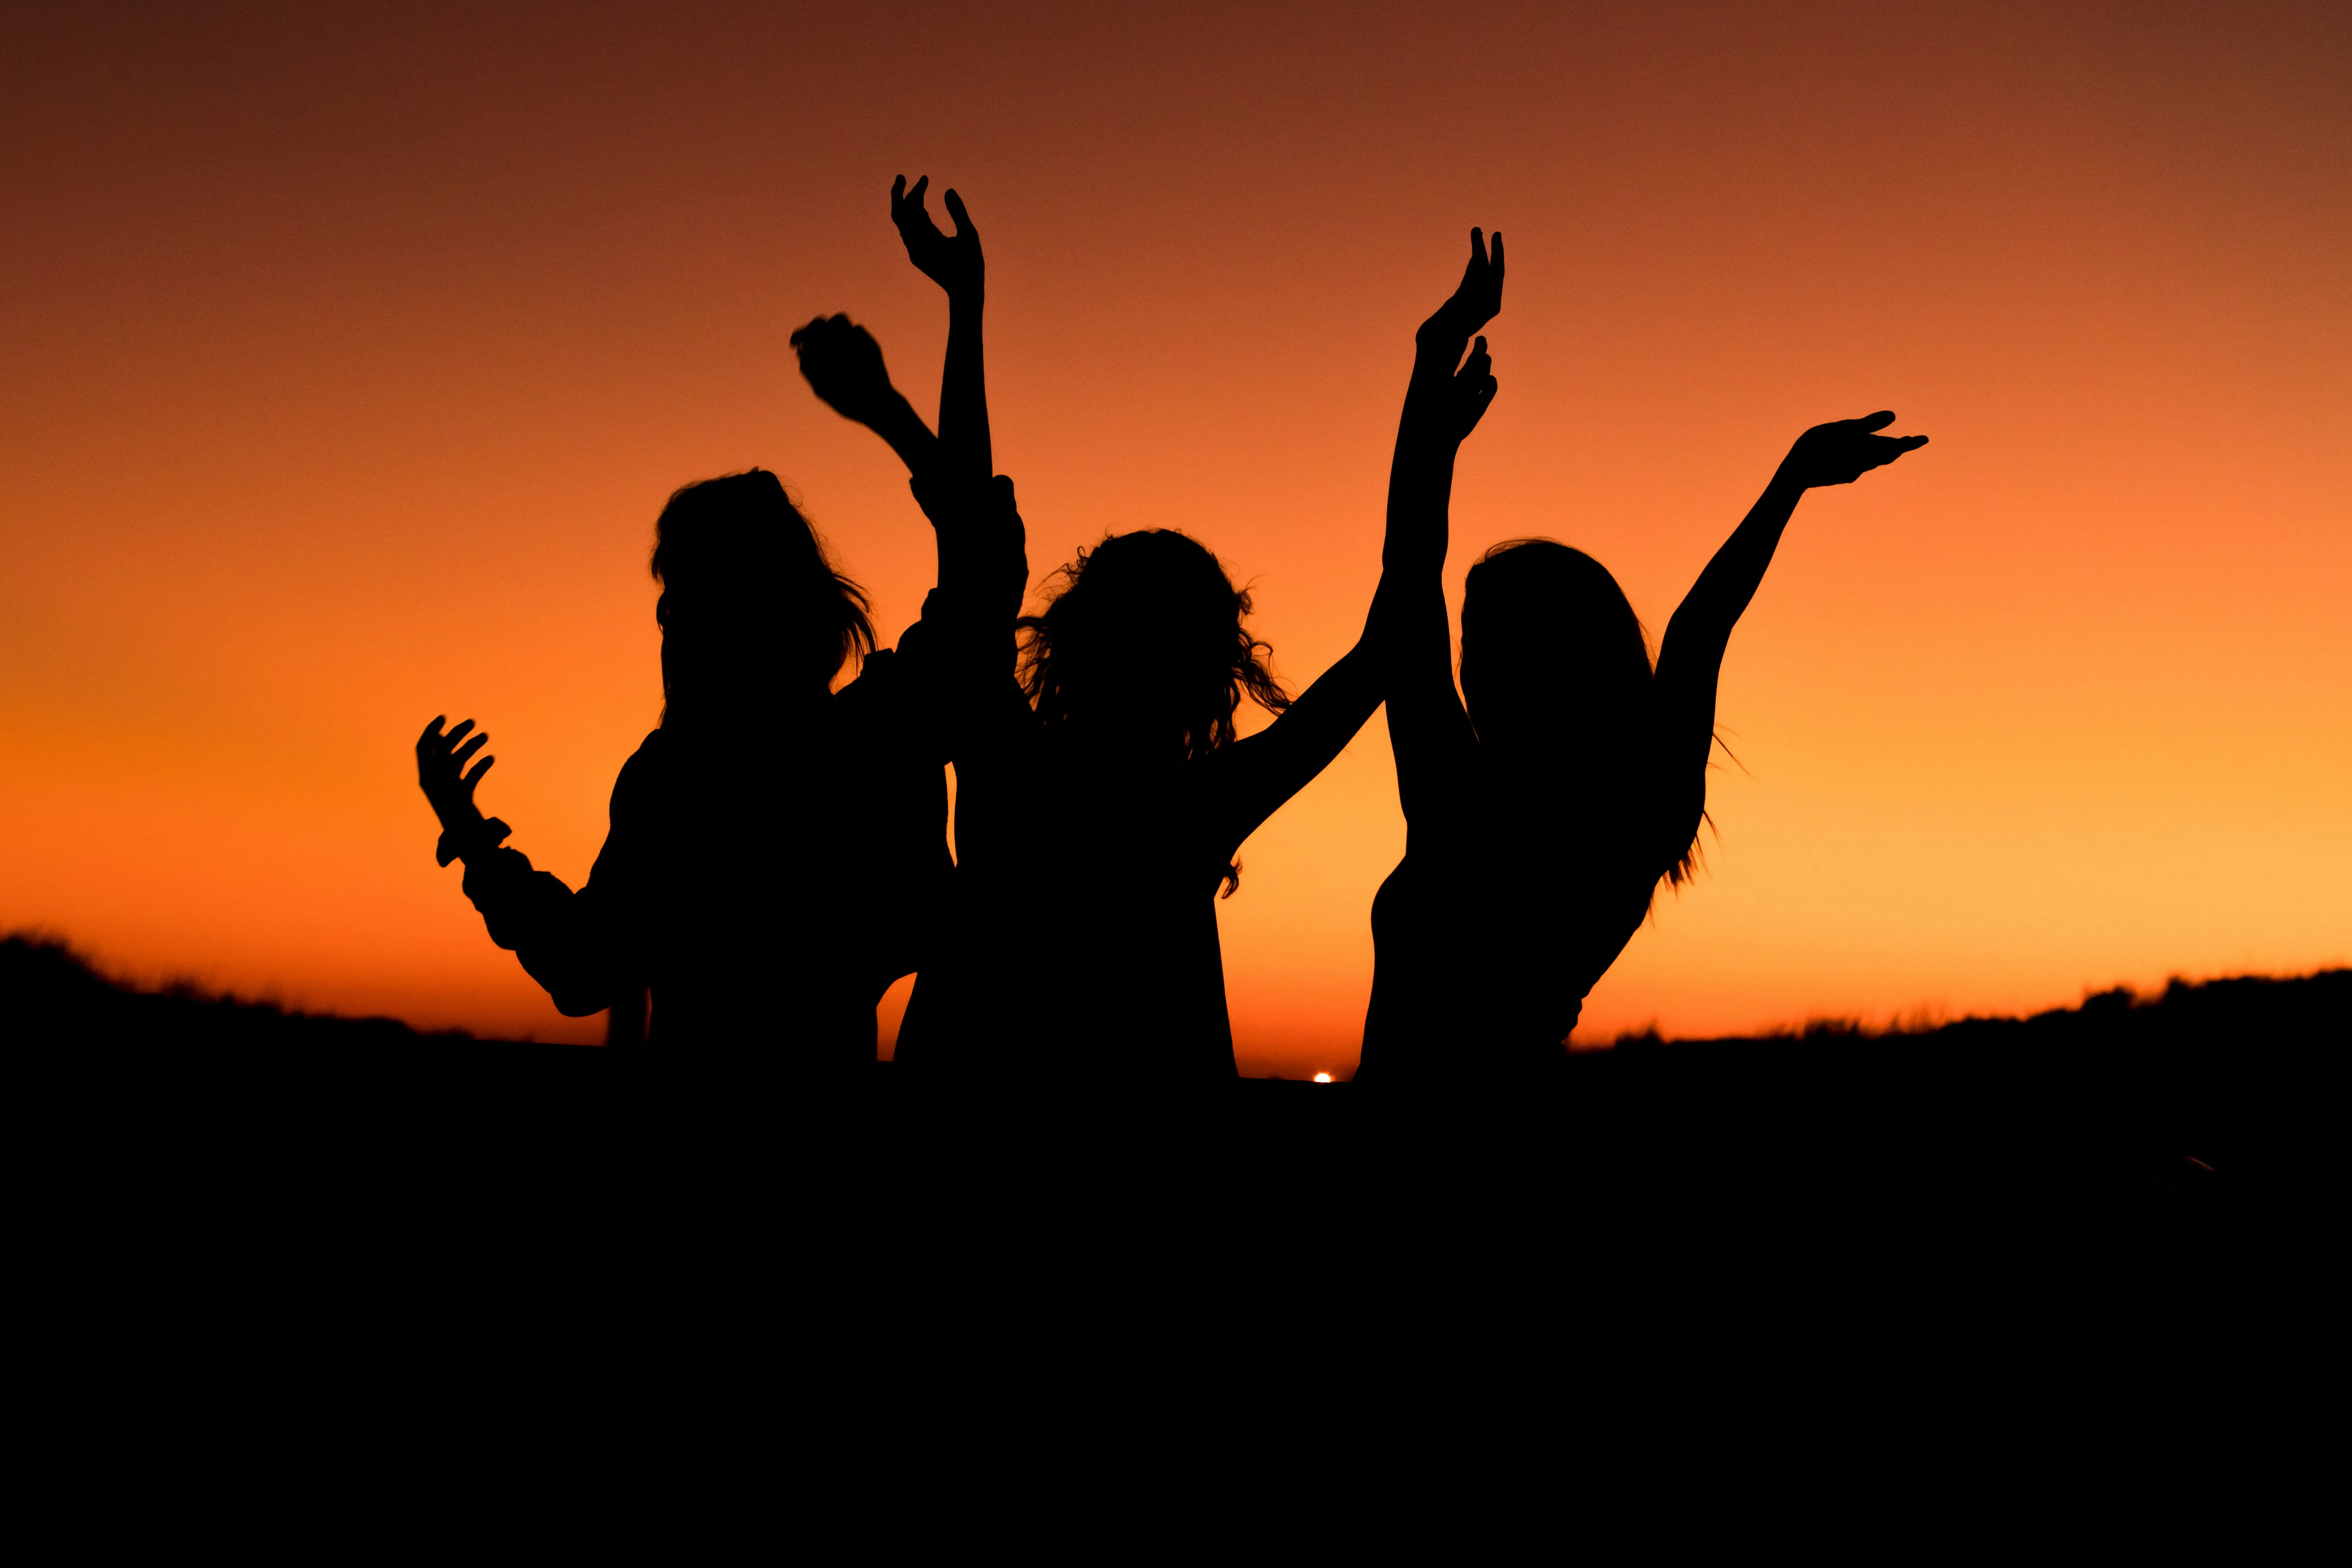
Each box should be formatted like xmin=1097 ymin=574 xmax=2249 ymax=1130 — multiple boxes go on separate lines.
xmin=466 ymin=635 xmax=948 ymax=1074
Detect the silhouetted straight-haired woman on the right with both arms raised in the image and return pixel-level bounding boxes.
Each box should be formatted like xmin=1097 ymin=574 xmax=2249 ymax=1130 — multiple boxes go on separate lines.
xmin=1357 ymin=259 xmax=1926 ymax=1084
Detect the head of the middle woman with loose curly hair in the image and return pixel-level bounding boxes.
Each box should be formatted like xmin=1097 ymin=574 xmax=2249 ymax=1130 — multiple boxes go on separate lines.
xmin=1021 ymin=529 xmax=1289 ymax=764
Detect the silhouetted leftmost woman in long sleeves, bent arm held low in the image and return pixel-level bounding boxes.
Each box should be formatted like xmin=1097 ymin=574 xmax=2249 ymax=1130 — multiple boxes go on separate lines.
xmin=416 ymin=468 xmax=948 ymax=1077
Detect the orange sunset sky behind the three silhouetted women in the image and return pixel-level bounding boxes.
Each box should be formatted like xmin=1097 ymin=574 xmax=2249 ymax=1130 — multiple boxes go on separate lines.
xmin=0 ymin=2 xmax=2352 ymax=1074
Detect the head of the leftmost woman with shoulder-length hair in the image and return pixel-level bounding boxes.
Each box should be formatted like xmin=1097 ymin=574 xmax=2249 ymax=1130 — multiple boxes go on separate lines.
xmin=654 ymin=468 xmax=875 ymax=724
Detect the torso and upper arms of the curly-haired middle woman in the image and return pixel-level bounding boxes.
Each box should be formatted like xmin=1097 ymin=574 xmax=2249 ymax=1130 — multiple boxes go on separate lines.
xmin=898 ymin=479 xmax=1381 ymax=1089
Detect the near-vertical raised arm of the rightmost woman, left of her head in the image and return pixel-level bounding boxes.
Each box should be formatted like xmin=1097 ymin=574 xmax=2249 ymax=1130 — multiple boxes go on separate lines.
xmin=1383 ymin=228 xmax=1503 ymax=825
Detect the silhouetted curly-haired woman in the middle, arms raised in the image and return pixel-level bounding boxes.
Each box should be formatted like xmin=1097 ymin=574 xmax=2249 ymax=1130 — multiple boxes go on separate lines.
xmin=804 ymin=186 xmax=1484 ymax=1086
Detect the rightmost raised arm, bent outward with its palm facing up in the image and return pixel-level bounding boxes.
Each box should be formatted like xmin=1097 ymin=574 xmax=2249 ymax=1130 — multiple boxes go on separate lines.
xmin=1656 ymin=411 xmax=1926 ymax=778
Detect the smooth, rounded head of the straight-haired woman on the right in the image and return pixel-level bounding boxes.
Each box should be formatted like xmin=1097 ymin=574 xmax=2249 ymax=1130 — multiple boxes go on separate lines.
xmin=1463 ymin=538 xmax=1651 ymax=776
